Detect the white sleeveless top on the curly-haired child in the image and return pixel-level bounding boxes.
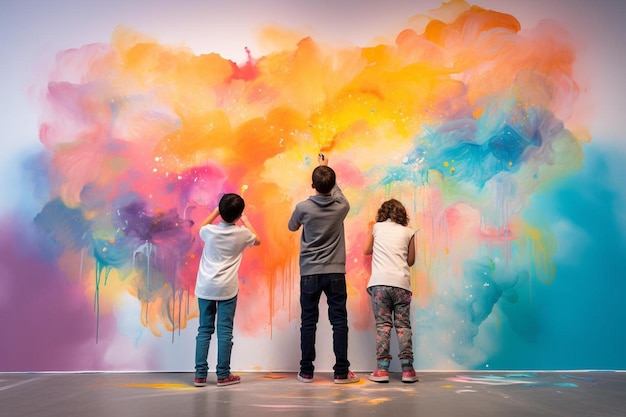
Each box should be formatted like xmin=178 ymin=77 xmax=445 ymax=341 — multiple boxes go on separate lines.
xmin=367 ymin=219 xmax=414 ymax=291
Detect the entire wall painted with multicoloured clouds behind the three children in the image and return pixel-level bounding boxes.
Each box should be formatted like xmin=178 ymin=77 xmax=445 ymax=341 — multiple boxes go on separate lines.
xmin=0 ymin=0 xmax=626 ymax=371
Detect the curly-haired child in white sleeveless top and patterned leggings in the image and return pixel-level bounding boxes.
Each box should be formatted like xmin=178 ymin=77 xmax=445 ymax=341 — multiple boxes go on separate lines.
xmin=365 ymin=199 xmax=418 ymax=383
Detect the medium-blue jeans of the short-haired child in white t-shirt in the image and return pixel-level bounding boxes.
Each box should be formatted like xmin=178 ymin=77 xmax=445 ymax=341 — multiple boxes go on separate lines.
xmin=196 ymin=296 xmax=237 ymax=379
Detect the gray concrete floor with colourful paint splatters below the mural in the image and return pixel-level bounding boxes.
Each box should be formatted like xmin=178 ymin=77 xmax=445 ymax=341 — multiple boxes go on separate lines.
xmin=0 ymin=372 xmax=626 ymax=417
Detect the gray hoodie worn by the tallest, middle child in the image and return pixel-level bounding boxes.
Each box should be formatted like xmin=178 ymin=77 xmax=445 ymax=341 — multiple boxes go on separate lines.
xmin=288 ymin=185 xmax=350 ymax=275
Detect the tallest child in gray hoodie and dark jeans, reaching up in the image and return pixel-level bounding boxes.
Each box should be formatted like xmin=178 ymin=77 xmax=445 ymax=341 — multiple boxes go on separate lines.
xmin=288 ymin=154 xmax=359 ymax=384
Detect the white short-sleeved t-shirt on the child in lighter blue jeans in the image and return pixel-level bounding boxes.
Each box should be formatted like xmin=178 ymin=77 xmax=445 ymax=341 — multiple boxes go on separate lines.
xmin=195 ymin=222 xmax=256 ymax=300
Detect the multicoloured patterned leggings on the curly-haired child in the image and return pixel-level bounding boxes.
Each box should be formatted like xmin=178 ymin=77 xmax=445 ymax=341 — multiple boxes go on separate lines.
xmin=368 ymin=285 xmax=413 ymax=367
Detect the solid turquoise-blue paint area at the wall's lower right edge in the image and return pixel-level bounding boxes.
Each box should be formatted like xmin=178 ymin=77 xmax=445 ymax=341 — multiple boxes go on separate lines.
xmin=488 ymin=145 xmax=626 ymax=370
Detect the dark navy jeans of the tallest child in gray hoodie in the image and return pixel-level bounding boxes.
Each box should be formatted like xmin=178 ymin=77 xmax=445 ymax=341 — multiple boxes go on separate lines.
xmin=300 ymin=274 xmax=350 ymax=376
